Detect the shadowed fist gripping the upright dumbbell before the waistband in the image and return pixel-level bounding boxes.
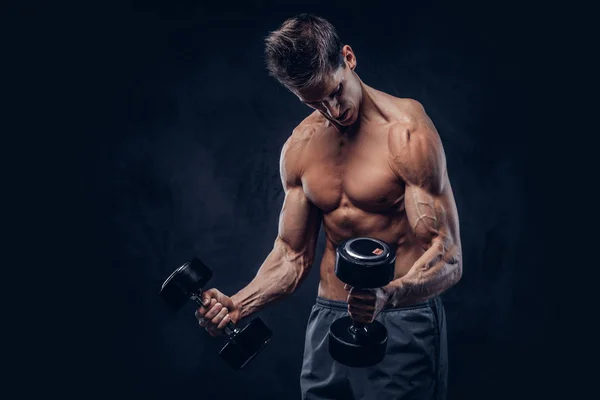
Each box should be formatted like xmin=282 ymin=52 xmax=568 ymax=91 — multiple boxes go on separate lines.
xmin=344 ymin=285 xmax=390 ymax=324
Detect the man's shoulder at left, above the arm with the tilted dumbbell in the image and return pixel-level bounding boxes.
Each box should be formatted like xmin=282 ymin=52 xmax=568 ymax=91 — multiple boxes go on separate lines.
xmin=279 ymin=114 xmax=319 ymax=187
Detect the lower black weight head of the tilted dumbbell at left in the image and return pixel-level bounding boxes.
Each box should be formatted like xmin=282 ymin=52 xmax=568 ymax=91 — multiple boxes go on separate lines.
xmin=219 ymin=318 xmax=273 ymax=370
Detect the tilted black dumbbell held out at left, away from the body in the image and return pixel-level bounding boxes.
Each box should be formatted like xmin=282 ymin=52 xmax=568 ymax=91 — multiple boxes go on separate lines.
xmin=160 ymin=258 xmax=273 ymax=370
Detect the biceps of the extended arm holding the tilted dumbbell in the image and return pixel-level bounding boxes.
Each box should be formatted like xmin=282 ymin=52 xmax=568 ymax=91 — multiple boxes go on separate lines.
xmin=279 ymin=187 xmax=321 ymax=254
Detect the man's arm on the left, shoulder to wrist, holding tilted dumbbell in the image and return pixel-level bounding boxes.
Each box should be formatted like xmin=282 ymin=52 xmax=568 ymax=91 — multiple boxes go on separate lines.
xmin=231 ymin=136 xmax=321 ymax=320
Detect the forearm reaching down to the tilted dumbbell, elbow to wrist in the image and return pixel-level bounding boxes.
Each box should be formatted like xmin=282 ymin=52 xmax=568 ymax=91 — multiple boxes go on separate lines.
xmin=231 ymin=239 xmax=313 ymax=319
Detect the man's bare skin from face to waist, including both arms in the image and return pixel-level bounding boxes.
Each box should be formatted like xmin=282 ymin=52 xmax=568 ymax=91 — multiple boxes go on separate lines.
xmin=196 ymin=45 xmax=462 ymax=336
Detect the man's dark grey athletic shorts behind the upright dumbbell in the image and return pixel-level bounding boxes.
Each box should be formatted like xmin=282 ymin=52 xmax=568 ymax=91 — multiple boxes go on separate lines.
xmin=300 ymin=297 xmax=448 ymax=400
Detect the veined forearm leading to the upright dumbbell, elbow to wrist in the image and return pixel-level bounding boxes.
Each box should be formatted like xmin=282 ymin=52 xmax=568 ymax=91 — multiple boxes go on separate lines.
xmin=388 ymin=238 xmax=462 ymax=307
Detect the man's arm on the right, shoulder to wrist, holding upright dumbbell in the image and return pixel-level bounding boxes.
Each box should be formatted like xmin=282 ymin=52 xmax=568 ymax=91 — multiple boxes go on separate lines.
xmin=386 ymin=102 xmax=462 ymax=306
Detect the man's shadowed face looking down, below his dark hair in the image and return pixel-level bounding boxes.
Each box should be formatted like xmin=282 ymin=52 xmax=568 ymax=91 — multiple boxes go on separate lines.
xmin=294 ymin=49 xmax=362 ymax=126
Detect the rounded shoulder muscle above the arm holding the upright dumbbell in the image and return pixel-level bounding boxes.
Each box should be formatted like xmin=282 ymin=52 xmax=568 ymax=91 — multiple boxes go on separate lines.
xmin=388 ymin=99 xmax=446 ymax=192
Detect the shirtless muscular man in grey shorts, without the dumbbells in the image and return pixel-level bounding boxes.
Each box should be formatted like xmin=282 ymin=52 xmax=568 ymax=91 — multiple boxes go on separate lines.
xmin=196 ymin=14 xmax=462 ymax=400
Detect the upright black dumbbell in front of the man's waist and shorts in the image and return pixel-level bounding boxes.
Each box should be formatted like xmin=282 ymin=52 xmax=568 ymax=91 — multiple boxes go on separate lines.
xmin=329 ymin=237 xmax=396 ymax=367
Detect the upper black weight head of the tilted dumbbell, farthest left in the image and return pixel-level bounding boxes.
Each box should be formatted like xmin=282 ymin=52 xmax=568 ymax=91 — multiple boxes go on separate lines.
xmin=160 ymin=258 xmax=212 ymax=310
